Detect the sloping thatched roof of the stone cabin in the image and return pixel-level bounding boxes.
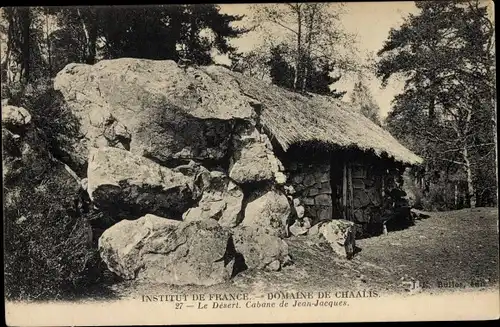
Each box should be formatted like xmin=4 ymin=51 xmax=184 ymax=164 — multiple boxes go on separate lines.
xmin=213 ymin=68 xmax=422 ymax=164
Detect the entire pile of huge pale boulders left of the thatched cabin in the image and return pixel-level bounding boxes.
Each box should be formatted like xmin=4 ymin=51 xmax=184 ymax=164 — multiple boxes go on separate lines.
xmin=50 ymin=59 xmax=292 ymax=285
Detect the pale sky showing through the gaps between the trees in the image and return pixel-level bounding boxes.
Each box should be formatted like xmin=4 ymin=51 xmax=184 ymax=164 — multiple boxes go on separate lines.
xmin=219 ymin=1 xmax=418 ymax=118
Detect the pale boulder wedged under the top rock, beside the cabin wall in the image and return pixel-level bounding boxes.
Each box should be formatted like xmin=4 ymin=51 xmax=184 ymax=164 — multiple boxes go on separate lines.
xmin=229 ymin=124 xmax=286 ymax=184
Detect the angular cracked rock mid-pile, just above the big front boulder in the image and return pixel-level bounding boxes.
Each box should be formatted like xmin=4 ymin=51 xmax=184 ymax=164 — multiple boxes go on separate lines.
xmin=182 ymin=171 xmax=243 ymax=227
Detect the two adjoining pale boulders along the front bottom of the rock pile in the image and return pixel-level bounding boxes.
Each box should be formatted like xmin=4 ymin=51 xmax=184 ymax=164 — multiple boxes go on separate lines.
xmin=99 ymin=214 xmax=290 ymax=285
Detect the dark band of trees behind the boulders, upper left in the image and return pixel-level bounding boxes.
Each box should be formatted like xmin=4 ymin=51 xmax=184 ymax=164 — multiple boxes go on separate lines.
xmin=1 ymin=4 xmax=247 ymax=84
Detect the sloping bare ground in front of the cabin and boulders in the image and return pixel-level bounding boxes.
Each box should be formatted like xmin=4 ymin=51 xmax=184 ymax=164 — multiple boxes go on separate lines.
xmin=95 ymin=208 xmax=499 ymax=298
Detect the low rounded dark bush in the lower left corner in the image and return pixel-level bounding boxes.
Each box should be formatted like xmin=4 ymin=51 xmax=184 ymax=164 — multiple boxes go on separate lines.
xmin=4 ymin=162 xmax=94 ymax=300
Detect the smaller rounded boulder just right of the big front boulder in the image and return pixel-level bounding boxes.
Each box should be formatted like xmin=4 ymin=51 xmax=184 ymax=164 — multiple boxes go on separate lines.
xmin=232 ymin=227 xmax=291 ymax=270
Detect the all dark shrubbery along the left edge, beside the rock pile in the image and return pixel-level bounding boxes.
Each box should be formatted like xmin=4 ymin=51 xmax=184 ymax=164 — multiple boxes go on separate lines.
xmin=2 ymin=79 xmax=106 ymax=300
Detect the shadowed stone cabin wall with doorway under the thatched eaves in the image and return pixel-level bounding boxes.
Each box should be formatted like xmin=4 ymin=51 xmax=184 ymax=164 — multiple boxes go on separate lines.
xmin=285 ymin=149 xmax=397 ymax=236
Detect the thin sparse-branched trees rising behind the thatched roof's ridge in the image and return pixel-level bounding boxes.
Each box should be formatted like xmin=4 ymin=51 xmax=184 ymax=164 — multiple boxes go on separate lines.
xmin=233 ymin=3 xmax=355 ymax=97
